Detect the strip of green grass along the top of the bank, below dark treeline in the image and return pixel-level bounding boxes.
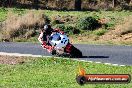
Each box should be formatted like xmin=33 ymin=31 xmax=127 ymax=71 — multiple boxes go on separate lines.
xmin=0 ymin=8 xmax=132 ymax=24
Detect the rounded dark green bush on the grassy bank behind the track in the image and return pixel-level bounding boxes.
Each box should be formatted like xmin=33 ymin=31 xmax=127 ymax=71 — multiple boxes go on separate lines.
xmin=76 ymin=17 xmax=100 ymax=30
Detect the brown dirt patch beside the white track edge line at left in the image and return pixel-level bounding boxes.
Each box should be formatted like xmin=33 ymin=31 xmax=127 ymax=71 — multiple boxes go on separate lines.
xmin=0 ymin=55 xmax=28 ymax=65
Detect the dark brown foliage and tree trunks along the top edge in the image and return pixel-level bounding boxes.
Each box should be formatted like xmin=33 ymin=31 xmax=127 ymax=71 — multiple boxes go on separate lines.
xmin=0 ymin=0 xmax=131 ymax=10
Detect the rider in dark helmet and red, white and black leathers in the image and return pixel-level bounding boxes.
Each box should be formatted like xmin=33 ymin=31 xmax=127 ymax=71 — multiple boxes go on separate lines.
xmin=38 ymin=25 xmax=64 ymax=53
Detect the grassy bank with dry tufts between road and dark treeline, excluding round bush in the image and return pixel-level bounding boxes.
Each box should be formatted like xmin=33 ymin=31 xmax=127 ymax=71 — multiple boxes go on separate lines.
xmin=0 ymin=8 xmax=132 ymax=45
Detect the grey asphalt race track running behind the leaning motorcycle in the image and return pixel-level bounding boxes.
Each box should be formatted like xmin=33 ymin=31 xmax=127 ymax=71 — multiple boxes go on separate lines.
xmin=0 ymin=42 xmax=132 ymax=65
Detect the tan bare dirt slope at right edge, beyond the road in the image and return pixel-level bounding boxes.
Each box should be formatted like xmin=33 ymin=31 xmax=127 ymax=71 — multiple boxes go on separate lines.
xmin=99 ymin=16 xmax=132 ymax=43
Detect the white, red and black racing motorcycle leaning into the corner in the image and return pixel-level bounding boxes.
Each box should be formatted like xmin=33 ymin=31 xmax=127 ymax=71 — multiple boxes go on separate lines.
xmin=49 ymin=32 xmax=82 ymax=58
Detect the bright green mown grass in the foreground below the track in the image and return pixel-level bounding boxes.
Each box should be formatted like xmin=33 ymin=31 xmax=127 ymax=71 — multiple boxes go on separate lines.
xmin=0 ymin=58 xmax=132 ymax=88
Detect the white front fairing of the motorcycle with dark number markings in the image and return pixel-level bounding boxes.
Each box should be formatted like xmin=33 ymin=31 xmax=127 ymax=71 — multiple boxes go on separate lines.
xmin=50 ymin=33 xmax=69 ymax=49
